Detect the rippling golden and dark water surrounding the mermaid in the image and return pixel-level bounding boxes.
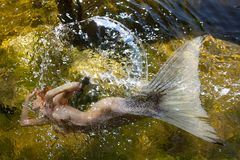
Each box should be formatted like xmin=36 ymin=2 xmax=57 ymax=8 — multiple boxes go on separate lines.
xmin=0 ymin=0 xmax=240 ymax=160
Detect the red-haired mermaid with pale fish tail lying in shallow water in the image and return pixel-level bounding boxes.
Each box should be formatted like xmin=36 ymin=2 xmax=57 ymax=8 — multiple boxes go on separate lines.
xmin=20 ymin=37 xmax=220 ymax=143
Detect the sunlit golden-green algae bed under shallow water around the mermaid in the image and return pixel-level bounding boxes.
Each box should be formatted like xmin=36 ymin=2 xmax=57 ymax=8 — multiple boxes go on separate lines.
xmin=0 ymin=0 xmax=240 ymax=160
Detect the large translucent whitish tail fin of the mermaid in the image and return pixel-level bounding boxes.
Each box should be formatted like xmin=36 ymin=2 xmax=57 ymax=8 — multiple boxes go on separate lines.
xmin=142 ymin=37 xmax=219 ymax=143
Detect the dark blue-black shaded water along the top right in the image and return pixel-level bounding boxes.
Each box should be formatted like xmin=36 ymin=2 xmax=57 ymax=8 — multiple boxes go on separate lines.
xmin=57 ymin=0 xmax=240 ymax=43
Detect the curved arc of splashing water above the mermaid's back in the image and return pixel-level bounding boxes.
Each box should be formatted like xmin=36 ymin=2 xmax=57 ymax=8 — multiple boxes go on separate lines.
xmin=54 ymin=16 xmax=148 ymax=88
